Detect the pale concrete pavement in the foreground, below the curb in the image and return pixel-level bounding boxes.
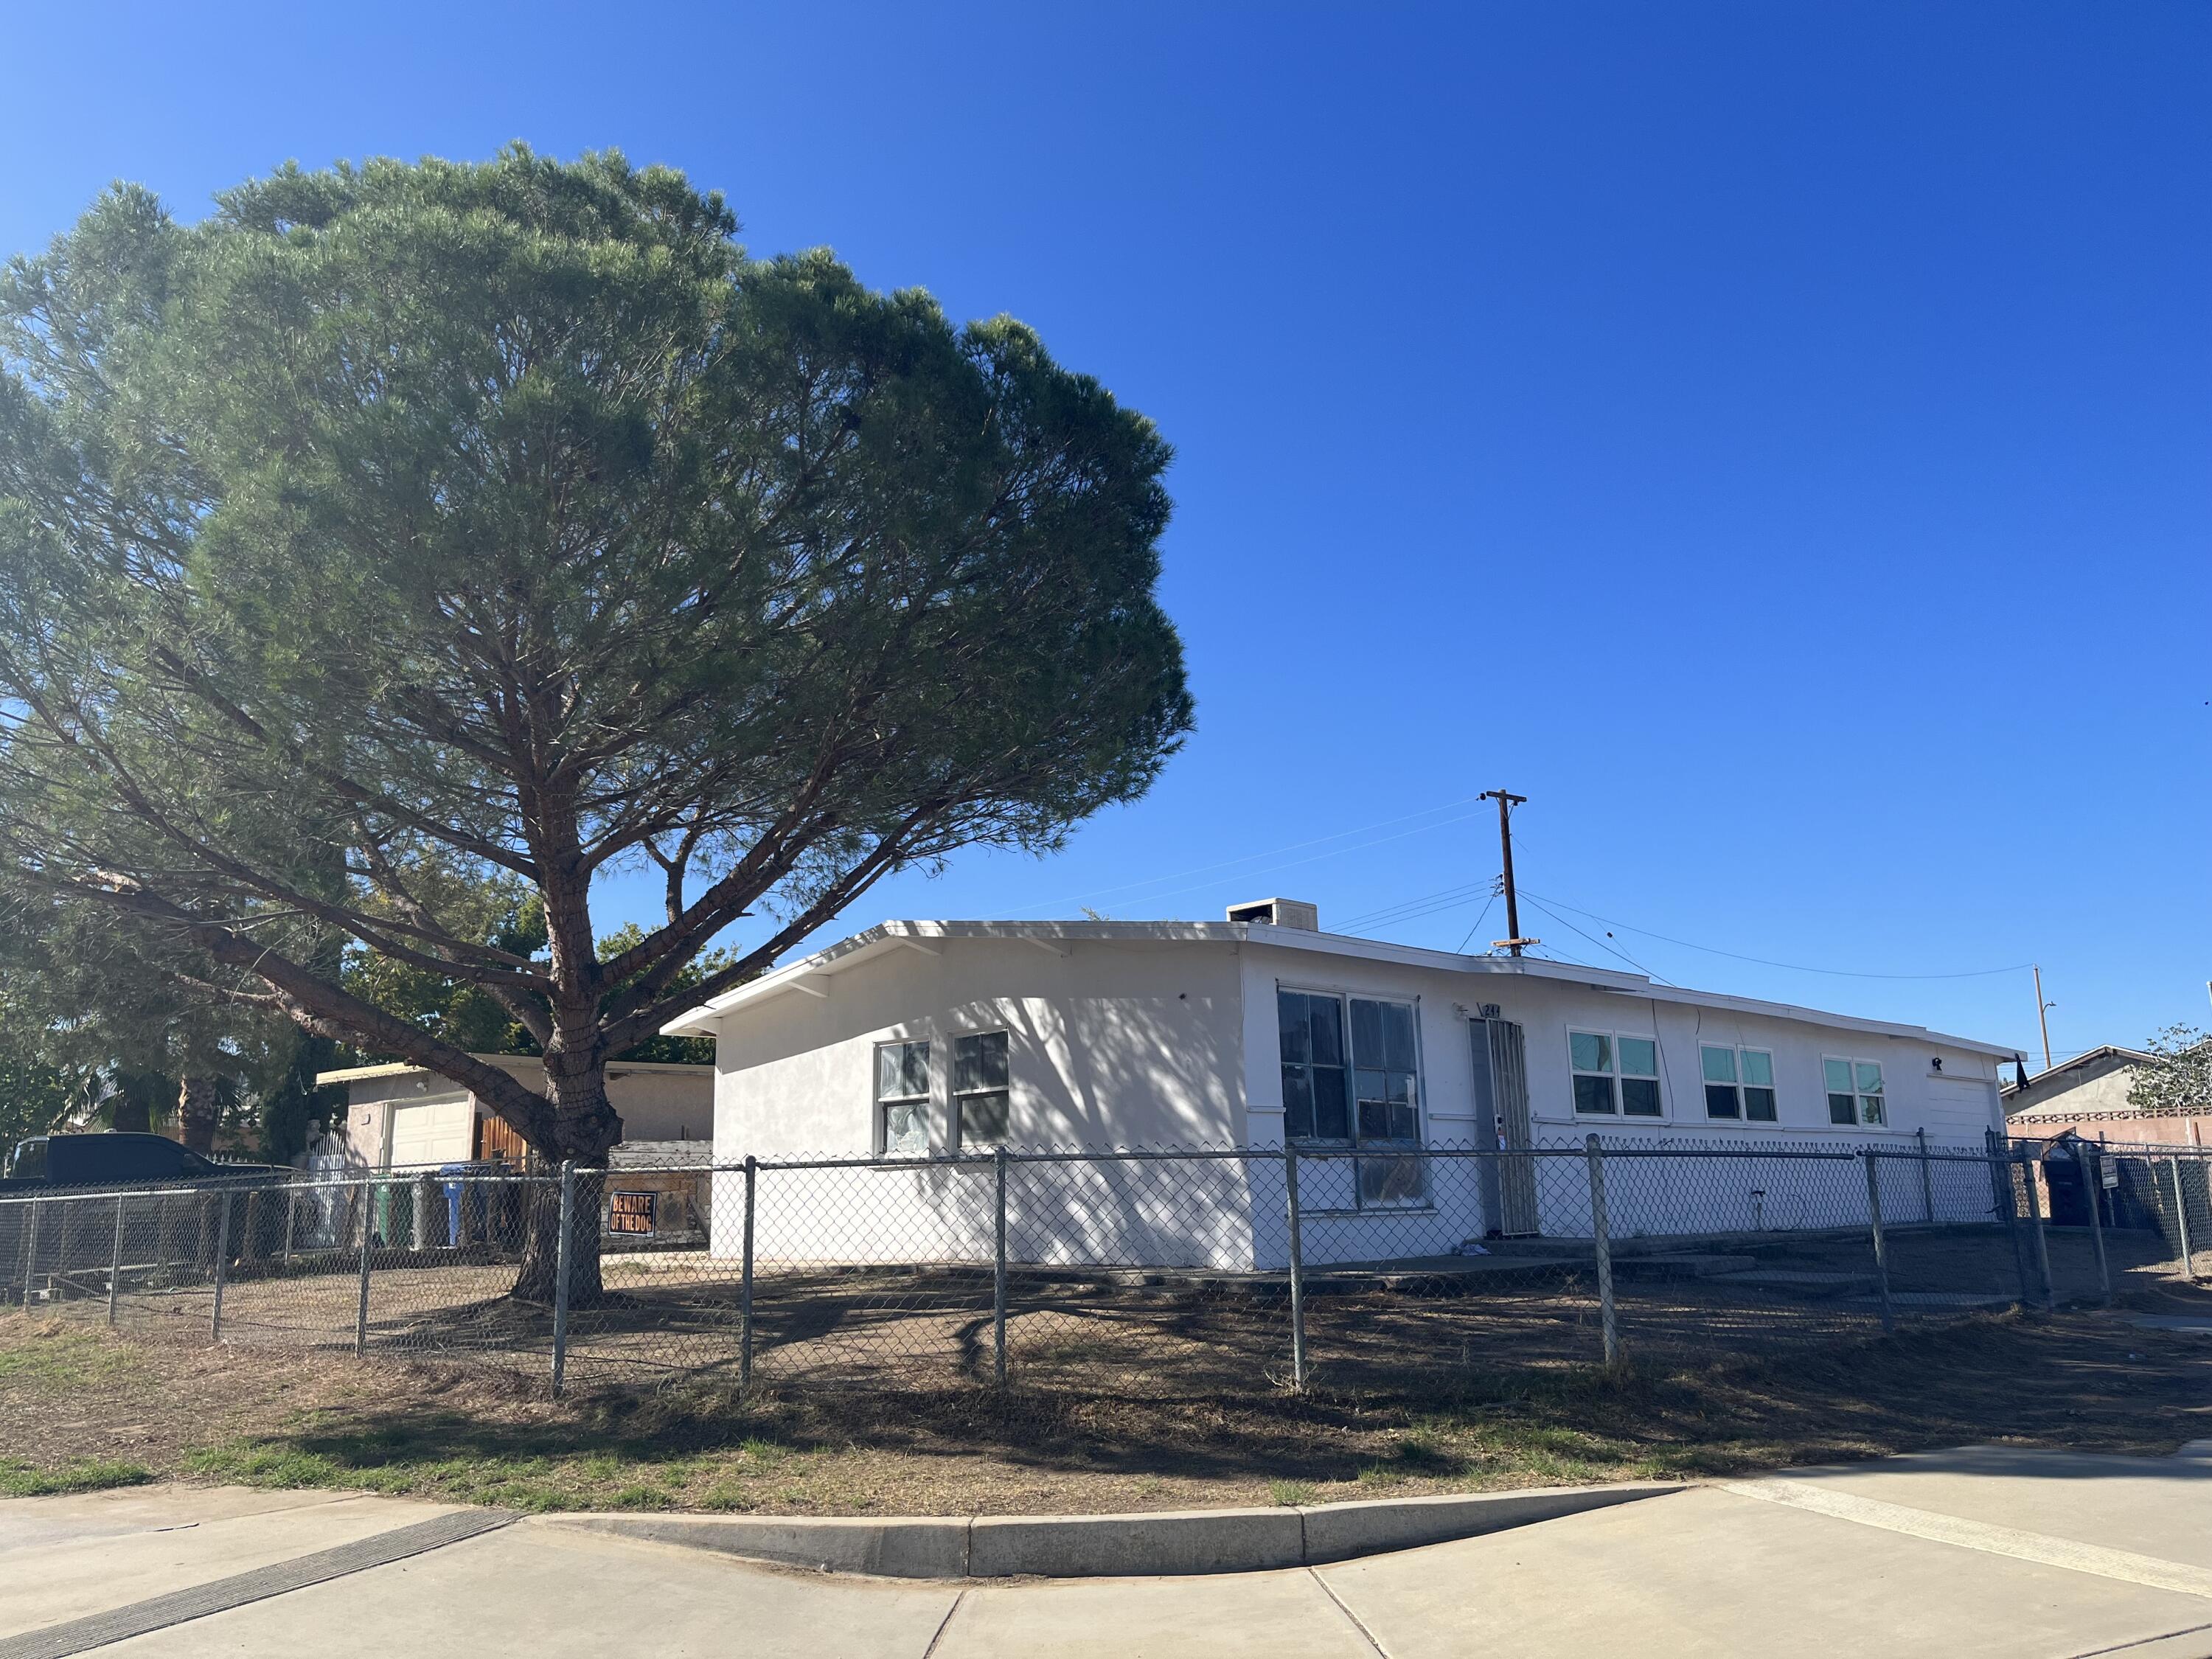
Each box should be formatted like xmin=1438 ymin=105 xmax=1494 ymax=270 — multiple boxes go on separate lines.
xmin=0 ymin=1449 xmax=2212 ymax=1659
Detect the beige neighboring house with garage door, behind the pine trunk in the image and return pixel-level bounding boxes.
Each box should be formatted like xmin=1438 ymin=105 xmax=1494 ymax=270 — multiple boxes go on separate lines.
xmin=314 ymin=1055 xmax=714 ymax=1170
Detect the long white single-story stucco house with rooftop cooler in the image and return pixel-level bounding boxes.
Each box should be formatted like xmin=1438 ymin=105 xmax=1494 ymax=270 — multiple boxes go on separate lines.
xmin=666 ymin=900 xmax=2011 ymax=1265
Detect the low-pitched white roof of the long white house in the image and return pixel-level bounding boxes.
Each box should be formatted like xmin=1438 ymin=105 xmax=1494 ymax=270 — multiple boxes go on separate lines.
xmin=661 ymin=920 xmax=2013 ymax=1060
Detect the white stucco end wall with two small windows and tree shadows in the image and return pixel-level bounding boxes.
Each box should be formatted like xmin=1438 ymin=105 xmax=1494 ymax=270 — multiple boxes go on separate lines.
xmin=714 ymin=938 xmax=1252 ymax=1267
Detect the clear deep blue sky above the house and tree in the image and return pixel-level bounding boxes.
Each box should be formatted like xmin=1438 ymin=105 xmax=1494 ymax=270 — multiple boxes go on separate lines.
xmin=0 ymin=0 xmax=2212 ymax=1057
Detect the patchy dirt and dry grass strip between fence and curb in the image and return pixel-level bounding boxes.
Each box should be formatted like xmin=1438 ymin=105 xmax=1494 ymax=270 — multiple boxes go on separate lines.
xmin=0 ymin=1298 xmax=2212 ymax=1515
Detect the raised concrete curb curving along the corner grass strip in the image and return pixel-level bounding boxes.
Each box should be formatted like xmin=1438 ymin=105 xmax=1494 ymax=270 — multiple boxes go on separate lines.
xmin=535 ymin=1480 xmax=1686 ymax=1579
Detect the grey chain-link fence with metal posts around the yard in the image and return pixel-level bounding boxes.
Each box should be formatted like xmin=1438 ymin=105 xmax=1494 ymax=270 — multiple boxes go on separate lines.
xmin=0 ymin=1135 xmax=2212 ymax=1400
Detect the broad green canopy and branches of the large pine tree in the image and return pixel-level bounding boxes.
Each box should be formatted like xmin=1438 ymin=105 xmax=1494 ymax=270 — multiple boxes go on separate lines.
xmin=0 ymin=146 xmax=1192 ymax=1221
